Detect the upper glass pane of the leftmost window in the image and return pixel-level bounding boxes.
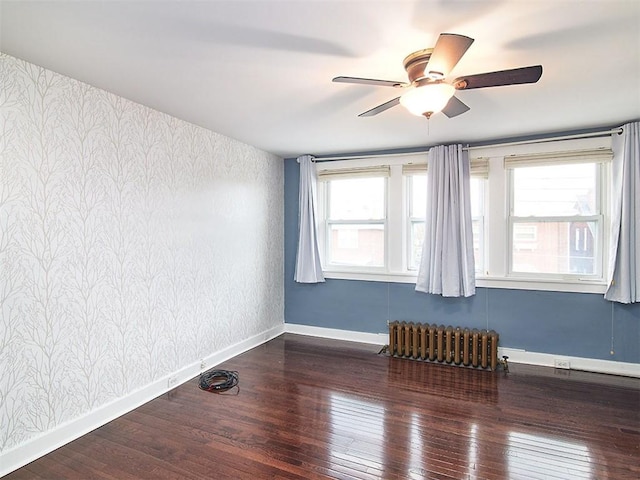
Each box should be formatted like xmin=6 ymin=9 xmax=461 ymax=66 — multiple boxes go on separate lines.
xmin=329 ymin=177 xmax=385 ymax=220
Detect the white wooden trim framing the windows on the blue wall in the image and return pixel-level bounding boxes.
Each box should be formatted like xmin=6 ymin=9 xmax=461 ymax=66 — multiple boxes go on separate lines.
xmin=318 ymin=136 xmax=611 ymax=294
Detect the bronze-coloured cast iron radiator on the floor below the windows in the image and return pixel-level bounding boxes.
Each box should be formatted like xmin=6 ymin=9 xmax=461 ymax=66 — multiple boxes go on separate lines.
xmin=388 ymin=321 xmax=499 ymax=370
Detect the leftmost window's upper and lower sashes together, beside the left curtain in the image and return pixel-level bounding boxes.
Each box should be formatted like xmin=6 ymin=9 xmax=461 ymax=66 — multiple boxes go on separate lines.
xmin=325 ymin=176 xmax=386 ymax=268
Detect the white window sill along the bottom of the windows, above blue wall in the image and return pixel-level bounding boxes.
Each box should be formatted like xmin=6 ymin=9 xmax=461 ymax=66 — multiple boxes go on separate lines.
xmin=323 ymin=270 xmax=607 ymax=294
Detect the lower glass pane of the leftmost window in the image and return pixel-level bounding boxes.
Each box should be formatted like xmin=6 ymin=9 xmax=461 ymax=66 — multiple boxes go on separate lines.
xmin=329 ymin=224 xmax=384 ymax=267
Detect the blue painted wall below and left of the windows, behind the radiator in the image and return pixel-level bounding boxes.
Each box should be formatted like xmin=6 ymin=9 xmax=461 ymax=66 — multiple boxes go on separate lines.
xmin=284 ymin=159 xmax=640 ymax=363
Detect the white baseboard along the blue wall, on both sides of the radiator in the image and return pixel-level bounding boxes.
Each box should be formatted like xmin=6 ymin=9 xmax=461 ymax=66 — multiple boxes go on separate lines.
xmin=284 ymin=323 xmax=640 ymax=377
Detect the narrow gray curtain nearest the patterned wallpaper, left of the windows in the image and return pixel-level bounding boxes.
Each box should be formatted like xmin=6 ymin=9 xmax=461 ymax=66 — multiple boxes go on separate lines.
xmin=294 ymin=155 xmax=324 ymax=283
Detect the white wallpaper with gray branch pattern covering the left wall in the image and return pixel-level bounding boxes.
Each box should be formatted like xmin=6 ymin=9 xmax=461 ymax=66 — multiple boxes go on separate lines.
xmin=0 ymin=54 xmax=284 ymax=452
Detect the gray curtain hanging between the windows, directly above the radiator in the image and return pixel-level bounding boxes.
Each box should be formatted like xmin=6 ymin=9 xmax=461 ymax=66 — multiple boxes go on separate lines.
xmin=416 ymin=145 xmax=476 ymax=297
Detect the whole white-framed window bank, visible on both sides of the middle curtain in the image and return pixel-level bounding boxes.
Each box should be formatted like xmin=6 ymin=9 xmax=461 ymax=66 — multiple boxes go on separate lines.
xmin=318 ymin=137 xmax=611 ymax=293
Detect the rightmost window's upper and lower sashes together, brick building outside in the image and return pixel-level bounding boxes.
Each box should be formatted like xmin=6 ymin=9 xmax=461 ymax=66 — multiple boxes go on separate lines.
xmin=509 ymin=162 xmax=604 ymax=278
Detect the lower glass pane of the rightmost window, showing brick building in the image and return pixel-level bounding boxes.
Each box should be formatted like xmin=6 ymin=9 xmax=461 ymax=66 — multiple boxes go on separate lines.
xmin=512 ymin=221 xmax=597 ymax=275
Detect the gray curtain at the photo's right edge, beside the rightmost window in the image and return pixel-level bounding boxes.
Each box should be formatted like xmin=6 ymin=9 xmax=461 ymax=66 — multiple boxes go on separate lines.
xmin=604 ymin=122 xmax=640 ymax=303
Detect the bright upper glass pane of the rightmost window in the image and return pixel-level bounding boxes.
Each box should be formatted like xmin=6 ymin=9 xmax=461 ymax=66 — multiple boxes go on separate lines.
xmin=513 ymin=163 xmax=599 ymax=217
